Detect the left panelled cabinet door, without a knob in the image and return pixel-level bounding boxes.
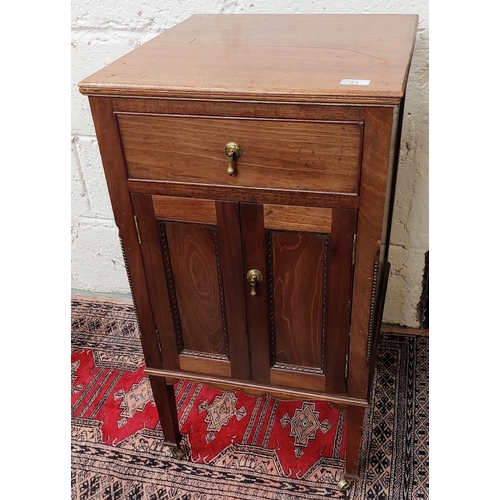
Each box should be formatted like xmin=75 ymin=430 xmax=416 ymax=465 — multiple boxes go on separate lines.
xmin=131 ymin=194 xmax=250 ymax=379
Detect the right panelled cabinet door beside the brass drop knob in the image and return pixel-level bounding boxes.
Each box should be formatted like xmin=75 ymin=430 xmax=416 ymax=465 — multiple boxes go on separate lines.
xmin=241 ymin=203 xmax=356 ymax=393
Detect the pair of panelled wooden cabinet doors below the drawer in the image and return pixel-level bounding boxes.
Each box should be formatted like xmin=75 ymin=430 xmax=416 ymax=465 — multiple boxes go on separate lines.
xmin=131 ymin=193 xmax=356 ymax=393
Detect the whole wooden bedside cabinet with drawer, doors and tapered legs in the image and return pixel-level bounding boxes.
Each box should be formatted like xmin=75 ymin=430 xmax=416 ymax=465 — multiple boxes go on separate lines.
xmin=80 ymin=15 xmax=417 ymax=488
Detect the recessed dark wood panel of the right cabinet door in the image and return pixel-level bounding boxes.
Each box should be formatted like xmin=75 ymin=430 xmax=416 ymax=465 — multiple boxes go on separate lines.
xmin=271 ymin=231 xmax=327 ymax=368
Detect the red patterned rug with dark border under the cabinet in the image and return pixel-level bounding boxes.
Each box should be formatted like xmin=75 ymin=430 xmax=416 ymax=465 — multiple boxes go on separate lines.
xmin=71 ymin=299 xmax=428 ymax=500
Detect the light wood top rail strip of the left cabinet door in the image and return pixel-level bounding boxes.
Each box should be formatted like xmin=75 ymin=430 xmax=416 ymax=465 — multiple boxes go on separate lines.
xmin=152 ymin=196 xmax=217 ymax=224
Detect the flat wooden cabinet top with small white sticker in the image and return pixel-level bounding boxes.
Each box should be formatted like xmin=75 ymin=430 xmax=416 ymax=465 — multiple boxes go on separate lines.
xmin=79 ymin=14 xmax=418 ymax=104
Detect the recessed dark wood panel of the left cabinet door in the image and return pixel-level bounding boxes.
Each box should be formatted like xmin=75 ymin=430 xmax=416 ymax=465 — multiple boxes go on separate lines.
xmin=164 ymin=222 xmax=227 ymax=354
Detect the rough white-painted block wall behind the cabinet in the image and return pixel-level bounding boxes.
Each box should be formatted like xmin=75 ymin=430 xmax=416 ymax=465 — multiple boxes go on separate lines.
xmin=71 ymin=0 xmax=429 ymax=327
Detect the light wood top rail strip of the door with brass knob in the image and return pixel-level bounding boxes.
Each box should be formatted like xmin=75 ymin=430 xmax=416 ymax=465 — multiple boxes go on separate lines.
xmin=264 ymin=205 xmax=332 ymax=233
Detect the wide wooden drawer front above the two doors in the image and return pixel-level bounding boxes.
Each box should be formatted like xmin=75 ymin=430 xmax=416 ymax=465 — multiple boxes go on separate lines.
xmin=117 ymin=114 xmax=363 ymax=194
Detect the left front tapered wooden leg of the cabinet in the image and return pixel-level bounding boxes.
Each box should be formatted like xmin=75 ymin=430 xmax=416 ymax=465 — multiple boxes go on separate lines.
xmin=149 ymin=375 xmax=182 ymax=448
